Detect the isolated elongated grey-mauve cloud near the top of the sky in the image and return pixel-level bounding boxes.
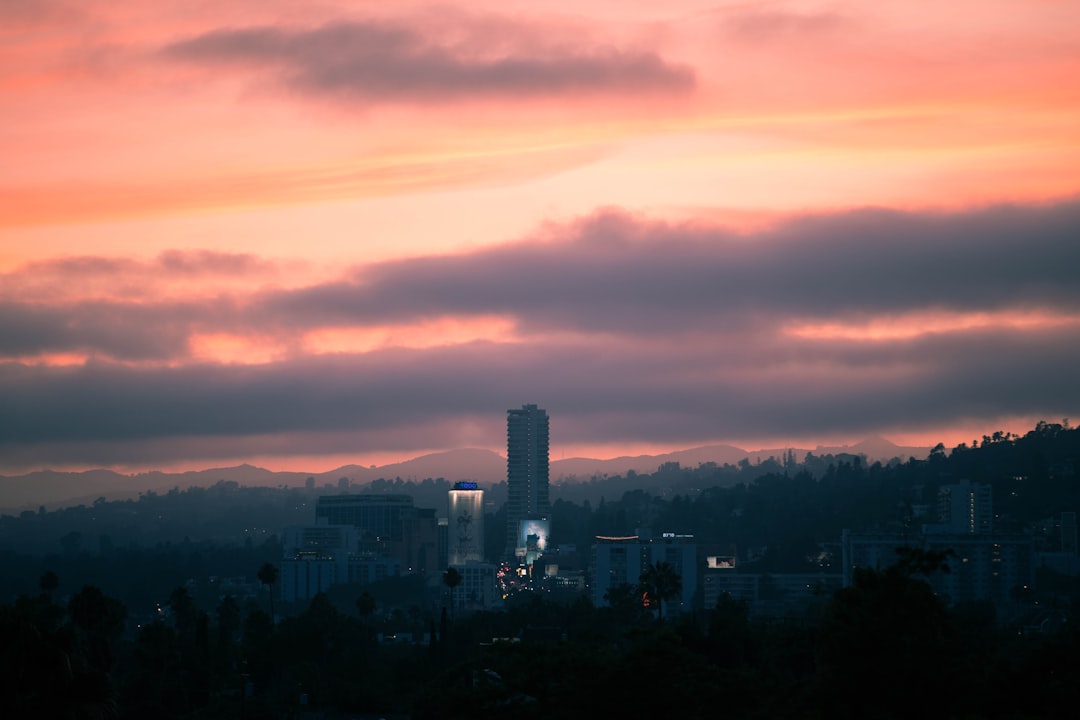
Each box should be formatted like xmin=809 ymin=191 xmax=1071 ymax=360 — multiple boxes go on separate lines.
xmin=164 ymin=22 xmax=694 ymax=100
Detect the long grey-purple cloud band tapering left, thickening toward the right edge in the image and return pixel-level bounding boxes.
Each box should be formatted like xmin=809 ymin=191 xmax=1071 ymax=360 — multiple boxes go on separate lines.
xmin=266 ymin=199 xmax=1080 ymax=332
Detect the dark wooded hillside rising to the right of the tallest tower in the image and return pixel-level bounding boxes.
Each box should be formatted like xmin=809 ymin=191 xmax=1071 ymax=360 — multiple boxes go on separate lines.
xmin=552 ymin=421 xmax=1080 ymax=572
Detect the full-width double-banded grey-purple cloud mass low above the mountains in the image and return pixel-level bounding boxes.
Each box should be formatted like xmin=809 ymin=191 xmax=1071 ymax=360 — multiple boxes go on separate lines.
xmin=0 ymin=197 xmax=1080 ymax=470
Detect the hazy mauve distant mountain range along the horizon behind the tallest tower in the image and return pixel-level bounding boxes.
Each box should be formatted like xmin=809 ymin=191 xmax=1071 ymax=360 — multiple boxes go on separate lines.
xmin=0 ymin=437 xmax=930 ymax=515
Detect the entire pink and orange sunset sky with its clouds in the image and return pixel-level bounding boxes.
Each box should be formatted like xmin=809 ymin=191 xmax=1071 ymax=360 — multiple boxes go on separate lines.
xmin=0 ymin=0 xmax=1080 ymax=474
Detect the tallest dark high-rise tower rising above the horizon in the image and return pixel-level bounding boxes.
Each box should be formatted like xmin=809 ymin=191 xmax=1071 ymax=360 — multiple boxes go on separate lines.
xmin=507 ymin=405 xmax=551 ymax=557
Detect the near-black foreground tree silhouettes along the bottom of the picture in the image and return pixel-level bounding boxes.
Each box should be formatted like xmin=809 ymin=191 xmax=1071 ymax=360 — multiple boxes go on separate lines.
xmin=6 ymin=553 xmax=1080 ymax=719
